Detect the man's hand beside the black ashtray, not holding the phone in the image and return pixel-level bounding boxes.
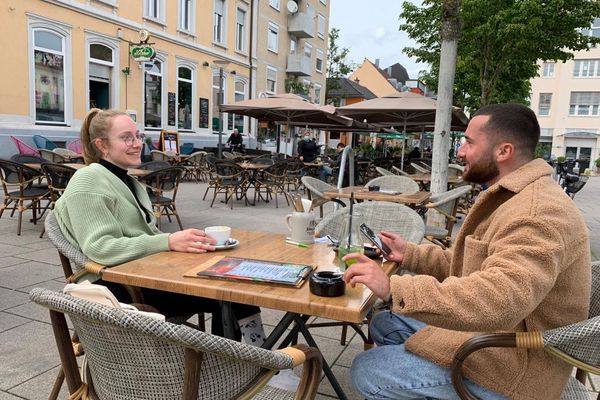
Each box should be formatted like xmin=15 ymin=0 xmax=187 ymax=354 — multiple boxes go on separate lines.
xmin=342 ymin=253 xmax=391 ymax=301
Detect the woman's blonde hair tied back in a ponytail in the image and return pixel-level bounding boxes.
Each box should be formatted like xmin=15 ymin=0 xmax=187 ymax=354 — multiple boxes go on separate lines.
xmin=80 ymin=108 xmax=127 ymax=165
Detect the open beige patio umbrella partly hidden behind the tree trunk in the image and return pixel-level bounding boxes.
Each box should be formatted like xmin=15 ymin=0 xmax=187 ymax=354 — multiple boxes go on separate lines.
xmin=337 ymin=92 xmax=469 ymax=166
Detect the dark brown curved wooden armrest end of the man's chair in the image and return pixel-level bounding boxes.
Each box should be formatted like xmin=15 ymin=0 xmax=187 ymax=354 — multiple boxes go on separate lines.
xmin=450 ymin=332 xmax=517 ymax=400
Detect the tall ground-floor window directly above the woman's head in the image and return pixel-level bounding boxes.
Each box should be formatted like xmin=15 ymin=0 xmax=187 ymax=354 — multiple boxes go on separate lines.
xmin=88 ymin=43 xmax=114 ymax=110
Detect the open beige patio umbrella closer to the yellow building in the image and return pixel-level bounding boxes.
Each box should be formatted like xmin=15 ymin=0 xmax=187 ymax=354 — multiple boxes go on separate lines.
xmin=221 ymin=93 xmax=353 ymax=155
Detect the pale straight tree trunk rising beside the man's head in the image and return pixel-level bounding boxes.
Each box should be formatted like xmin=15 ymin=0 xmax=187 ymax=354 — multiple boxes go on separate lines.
xmin=427 ymin=0 xmax=460 ymax=230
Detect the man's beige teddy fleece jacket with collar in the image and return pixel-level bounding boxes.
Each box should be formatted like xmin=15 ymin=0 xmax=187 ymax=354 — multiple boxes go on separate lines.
xmin=391 ymin=159 xmax=591 ymax=400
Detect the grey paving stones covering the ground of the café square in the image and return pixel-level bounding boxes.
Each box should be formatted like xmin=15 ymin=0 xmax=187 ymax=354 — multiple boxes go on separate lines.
xmin=0 ymin=178 xmax=600 ymax=400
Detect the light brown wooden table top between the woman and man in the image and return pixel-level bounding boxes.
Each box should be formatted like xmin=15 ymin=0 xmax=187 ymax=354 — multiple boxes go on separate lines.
xmin=103 ymin=229 xmax=396 ymax=323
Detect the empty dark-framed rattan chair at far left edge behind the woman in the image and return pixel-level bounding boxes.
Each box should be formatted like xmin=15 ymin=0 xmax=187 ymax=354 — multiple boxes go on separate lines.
xmin=0 ymin=160 xmax=50 ymax=235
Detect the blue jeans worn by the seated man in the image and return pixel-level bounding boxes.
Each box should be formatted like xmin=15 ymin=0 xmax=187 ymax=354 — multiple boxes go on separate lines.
xmin=350 ymin=311 xmax=506 ymax=400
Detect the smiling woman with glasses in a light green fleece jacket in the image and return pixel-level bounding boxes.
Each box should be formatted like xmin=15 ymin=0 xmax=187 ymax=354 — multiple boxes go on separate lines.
xmin=54 ymin=109 xmax=265 ymax=346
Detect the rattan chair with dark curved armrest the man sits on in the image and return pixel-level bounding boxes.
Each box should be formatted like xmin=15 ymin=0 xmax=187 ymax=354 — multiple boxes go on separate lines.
xmin=452 ymin=261 xmax=600 ymax=400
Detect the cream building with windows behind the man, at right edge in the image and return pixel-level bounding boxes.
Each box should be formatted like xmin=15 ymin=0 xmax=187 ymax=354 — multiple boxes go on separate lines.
xmin=531 ymin=18 xmax=600 ymax=171
